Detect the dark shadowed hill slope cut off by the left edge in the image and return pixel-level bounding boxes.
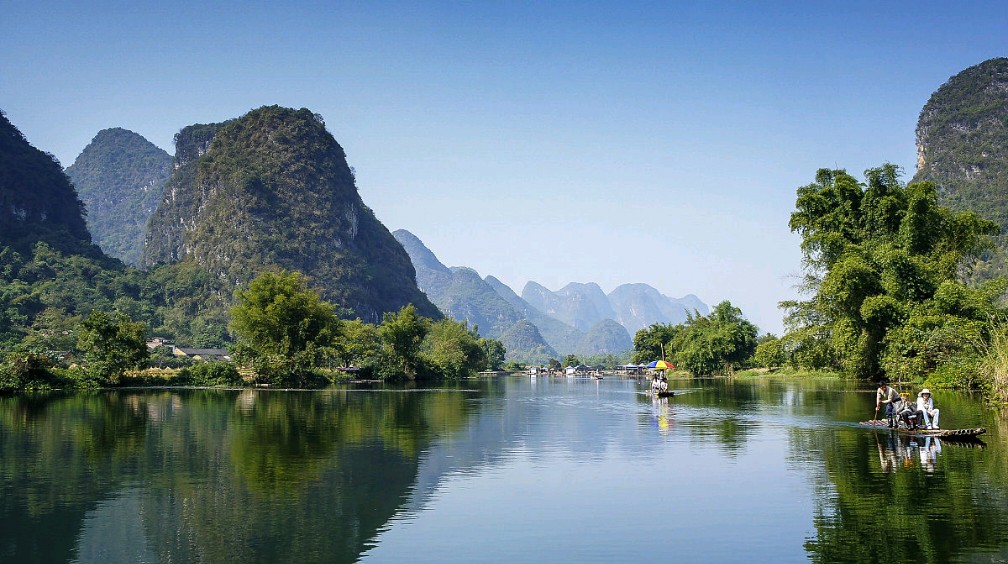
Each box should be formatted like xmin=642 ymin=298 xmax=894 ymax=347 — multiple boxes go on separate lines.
xmin=0 ymin=112 xmax=101 ymax=257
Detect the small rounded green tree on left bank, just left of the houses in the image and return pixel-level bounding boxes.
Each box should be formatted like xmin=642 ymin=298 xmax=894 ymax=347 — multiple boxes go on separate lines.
xmin=77 ymin=309 xmax=149 ymax=384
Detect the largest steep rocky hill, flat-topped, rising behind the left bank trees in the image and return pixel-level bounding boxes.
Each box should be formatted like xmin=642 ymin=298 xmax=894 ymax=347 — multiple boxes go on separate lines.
xmin=143 ymin=106 xmax=440 ymax=321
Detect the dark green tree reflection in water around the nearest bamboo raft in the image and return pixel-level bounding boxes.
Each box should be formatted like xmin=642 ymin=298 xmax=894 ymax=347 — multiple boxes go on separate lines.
xmin=794 ymin=430 xmax=1008 ymax=562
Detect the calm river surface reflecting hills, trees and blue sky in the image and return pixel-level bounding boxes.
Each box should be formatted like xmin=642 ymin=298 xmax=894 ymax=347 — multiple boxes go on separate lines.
xmin=0 ymin=377 xmax=1008 ymax=563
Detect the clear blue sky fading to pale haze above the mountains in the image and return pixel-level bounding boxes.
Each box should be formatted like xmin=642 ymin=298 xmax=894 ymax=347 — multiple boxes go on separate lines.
xmin=0 ymin=0 xmax=1008 ymax=332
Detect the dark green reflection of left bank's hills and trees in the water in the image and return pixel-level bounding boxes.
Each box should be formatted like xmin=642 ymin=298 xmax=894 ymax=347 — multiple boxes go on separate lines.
xmin=0 ymin=390 xmax=472 ymax=562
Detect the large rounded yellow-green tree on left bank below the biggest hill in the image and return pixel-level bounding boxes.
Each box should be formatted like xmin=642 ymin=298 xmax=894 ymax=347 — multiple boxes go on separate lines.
xmin=231 ymin=270 xmax=340 ymax=385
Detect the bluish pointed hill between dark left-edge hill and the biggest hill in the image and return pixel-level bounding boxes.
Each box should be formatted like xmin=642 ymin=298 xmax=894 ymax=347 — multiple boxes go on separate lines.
xmin=67 ymin=128 xmax=171 ymax=264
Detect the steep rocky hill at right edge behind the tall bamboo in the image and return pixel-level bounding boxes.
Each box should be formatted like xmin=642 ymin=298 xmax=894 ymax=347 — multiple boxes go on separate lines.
xmin=913 ymin=57 xmax=1008 ymax=278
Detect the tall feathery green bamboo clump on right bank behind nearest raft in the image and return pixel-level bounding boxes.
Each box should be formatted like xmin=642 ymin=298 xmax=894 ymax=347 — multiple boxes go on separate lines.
xmin=781 ymin=164 xmax=1004 ymax=380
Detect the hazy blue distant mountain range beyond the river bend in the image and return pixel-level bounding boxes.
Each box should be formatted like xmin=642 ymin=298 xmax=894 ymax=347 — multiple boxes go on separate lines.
xmin=392 ymin=230 xmax=709 ymax=363
